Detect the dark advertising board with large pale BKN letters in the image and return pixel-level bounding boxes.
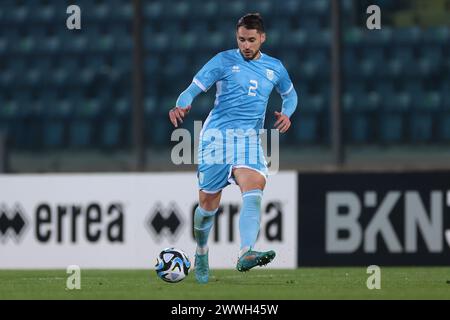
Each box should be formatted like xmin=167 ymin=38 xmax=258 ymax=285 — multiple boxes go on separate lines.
xmin=298 ymin=172 xmax=450 ymax=266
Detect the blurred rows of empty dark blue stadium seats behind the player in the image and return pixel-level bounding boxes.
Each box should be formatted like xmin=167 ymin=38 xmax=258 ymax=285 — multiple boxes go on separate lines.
xmin=0 ymin=0 xmax=450 ymax=149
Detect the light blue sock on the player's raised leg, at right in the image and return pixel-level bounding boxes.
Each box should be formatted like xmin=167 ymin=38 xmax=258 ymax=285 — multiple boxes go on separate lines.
xmin=239 ymin=189 xmax=263 ymax=253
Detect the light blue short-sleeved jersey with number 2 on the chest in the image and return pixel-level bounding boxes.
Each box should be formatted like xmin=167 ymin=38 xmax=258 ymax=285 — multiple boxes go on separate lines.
xmin=193 ymin=49 xmax=294 ymax=136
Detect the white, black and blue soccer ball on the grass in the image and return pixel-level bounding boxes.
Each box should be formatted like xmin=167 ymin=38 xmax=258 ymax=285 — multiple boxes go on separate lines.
xmin=155 ymin=248 xmax=191 ymax=283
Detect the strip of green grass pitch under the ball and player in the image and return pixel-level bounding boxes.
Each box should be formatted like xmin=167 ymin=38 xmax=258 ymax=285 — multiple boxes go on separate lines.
xmin=0 ymin=267 xmax=450 ymax=300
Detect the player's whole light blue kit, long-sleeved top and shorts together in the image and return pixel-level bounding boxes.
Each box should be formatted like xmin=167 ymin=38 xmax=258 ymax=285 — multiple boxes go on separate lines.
xmin=176 ymin=49 xmax=297 ymax=193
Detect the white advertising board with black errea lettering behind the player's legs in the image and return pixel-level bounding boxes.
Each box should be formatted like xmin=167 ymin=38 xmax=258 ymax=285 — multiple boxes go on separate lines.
xmin=0 ymin=172 xmax=297 ymax=269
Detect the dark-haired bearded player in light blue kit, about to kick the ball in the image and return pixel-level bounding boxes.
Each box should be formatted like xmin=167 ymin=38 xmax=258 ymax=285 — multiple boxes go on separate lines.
xmin=169 ymin=13 xmax=297 ymax=283
